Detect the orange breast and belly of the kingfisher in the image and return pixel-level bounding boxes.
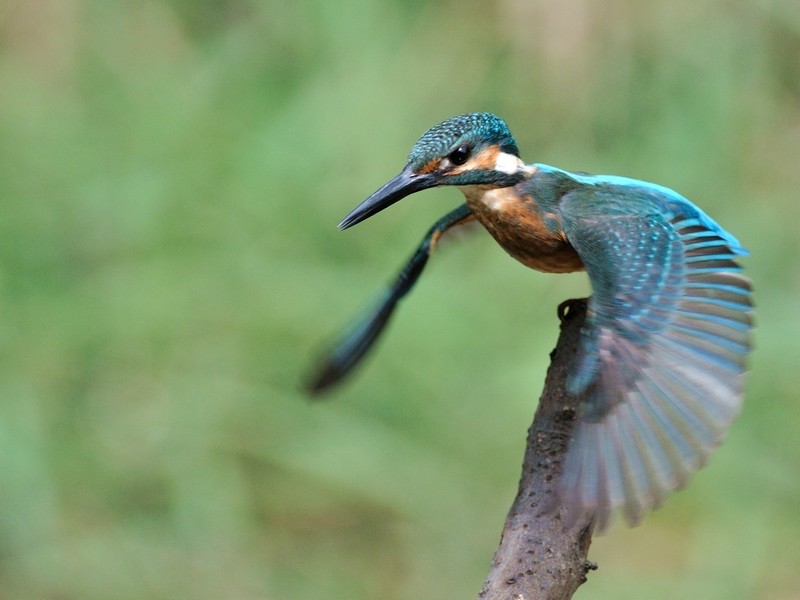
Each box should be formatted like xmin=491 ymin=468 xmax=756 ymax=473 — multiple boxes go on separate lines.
xmin=462 ymin=187 xmax=584 ymax=273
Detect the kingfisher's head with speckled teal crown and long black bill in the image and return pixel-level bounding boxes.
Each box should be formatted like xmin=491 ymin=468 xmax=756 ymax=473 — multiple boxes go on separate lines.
xmin=339 ymin=113 xmax=524 ymax=229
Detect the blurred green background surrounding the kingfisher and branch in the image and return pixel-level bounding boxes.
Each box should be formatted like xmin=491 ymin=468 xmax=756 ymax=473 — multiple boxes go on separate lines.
xmin=0 ymin=0 xmax=800 ymax=600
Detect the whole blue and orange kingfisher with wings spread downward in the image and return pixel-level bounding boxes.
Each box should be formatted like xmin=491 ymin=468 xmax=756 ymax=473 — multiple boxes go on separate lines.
xmin=309 ymin=112 xmax=753 ymax=530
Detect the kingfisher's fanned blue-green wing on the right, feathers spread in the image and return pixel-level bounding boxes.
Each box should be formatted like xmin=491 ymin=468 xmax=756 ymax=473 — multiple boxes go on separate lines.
xmin=559 ymin=185 xmax=752 ymax=530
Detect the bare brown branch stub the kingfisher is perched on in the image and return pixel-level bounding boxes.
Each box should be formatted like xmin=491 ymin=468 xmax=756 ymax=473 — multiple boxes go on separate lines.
xmin=478 ymin=300 xmax=597 ymax=600
